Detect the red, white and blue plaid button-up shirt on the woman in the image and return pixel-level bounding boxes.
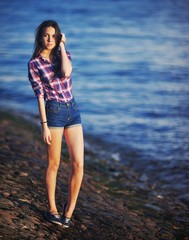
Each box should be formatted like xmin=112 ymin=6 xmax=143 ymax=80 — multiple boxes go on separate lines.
xmin=28 ymin=52 xmax=73 ymax=102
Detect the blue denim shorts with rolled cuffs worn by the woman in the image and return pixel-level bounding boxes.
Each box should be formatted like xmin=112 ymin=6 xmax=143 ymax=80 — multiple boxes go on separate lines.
xmin=45 ymin=98 xmax=81 ymax=128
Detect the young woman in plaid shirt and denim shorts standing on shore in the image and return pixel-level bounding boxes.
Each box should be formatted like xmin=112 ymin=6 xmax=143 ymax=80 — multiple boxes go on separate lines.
xmin=28 ymin=20 xmax=84 ymax=227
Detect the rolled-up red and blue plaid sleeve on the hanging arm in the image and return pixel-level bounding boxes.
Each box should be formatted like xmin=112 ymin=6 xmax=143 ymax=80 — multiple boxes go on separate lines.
xmin=28 ymin=61 xmax=44 ymax=98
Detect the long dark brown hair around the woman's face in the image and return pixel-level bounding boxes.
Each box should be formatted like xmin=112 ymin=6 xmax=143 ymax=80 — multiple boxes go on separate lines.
xmin=32 ymin=20 xmax=61 ymax=59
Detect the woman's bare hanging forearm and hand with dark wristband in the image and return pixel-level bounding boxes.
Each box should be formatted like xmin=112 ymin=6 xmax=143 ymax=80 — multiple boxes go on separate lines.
xmin=38 ymin=97 xmax=51 ymax=145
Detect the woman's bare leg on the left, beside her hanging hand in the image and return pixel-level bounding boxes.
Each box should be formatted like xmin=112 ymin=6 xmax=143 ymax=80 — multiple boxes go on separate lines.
xmin=46 ymin=128 xmax=64 ymax=214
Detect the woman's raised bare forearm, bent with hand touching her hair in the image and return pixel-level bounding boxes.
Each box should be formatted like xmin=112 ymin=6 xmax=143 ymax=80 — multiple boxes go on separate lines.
xmin=59 ymin=33 xmax=72 ymax=77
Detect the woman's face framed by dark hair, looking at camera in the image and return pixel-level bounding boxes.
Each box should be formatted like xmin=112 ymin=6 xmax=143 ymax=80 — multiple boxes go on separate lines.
xmin=42 ymin=27 xmax=56 ymax=50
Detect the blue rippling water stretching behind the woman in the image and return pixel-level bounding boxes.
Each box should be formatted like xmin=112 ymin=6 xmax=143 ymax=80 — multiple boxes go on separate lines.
xmin=0 ymin=0 xmax=189 ymax=193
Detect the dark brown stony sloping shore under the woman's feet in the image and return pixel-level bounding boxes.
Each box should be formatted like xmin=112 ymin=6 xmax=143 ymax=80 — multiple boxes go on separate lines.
xmin=0 ymin=110 xmax=189 ymax=240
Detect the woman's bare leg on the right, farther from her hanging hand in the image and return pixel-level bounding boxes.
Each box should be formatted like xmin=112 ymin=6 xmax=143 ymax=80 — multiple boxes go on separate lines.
xmin=65 ymin=126 xmax=84 ymax=218
